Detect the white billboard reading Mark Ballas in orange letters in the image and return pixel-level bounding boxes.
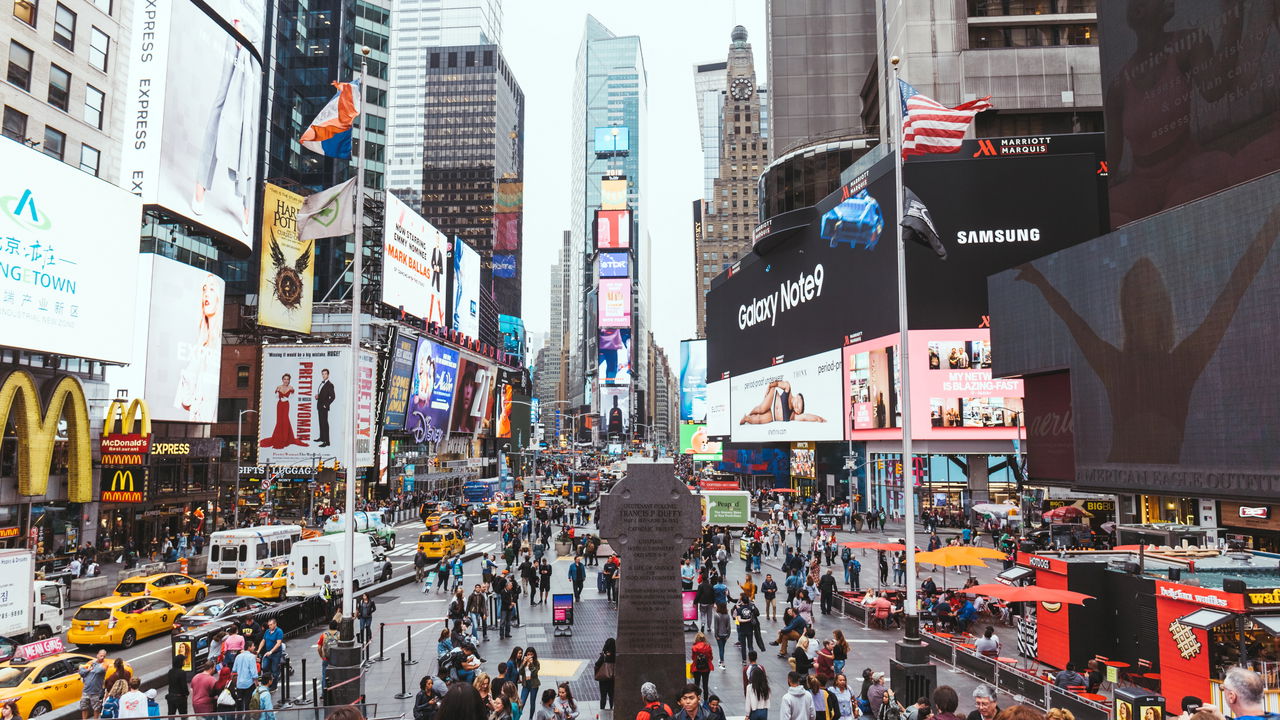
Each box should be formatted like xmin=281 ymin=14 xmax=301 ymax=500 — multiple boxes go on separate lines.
xmin=383 ymin=195 xmax=449 ymax=327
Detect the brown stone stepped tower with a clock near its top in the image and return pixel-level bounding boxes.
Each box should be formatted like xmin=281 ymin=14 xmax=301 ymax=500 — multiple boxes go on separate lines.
xmin=694 ymin=26 xmax=769 ymax=337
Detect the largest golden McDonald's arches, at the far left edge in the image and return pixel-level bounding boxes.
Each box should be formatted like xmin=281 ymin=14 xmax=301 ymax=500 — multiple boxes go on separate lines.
xmin=0 ymin=370 xmax=93 ymax=502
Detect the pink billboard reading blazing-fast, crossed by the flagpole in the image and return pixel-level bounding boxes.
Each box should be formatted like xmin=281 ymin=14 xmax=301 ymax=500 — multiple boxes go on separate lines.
xmin=844 ymin=328 xmax=1024 ymax=441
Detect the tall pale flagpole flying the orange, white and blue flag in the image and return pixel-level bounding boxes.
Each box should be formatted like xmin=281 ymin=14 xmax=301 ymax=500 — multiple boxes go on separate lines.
xmin=342 ymin=47 xmax=369 ymax=624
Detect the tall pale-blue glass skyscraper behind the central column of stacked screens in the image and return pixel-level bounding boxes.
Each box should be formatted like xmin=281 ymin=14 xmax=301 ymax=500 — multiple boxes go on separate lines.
xmin=567 ymin=15 xmax=649 ymax=423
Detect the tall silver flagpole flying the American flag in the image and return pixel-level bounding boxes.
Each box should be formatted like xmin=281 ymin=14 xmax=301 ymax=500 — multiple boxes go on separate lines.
xmin=888 ymin=55 xmax=920 ymax=643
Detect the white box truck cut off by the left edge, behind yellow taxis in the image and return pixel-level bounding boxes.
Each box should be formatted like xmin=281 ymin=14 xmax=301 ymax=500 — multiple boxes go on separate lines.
xmin=0 ymin=550 xmax=67 ymax=642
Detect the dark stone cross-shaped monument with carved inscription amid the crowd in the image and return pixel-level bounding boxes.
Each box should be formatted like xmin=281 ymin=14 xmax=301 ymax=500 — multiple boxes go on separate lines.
xmin=600 ymin=459 xmax=701 ymax=719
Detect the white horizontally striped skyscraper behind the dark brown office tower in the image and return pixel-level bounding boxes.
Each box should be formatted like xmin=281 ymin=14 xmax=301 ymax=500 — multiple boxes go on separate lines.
xmin=387 ymin=0 xmax=502 ymax=210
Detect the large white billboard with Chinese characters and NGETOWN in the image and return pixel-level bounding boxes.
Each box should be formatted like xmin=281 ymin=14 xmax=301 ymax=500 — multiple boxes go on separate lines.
xmin=0 ymin=142 xmax=142 ymax=363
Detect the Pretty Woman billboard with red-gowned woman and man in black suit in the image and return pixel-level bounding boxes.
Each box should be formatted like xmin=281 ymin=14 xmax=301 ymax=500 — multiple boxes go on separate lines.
xmin=257 ymin=345 xmax=353 ymax=465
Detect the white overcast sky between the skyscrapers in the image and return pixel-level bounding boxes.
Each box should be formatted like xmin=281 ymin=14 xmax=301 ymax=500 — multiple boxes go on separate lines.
xmin=502 ymin=0 xmax=768 ymax=365
